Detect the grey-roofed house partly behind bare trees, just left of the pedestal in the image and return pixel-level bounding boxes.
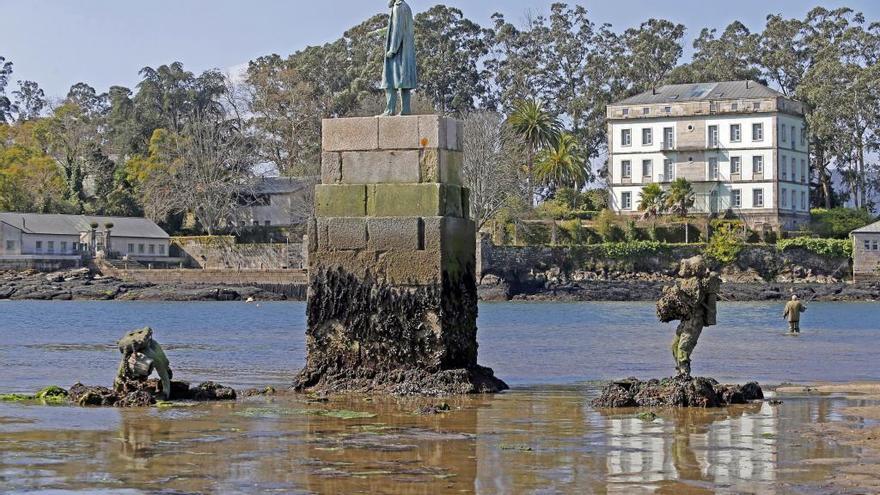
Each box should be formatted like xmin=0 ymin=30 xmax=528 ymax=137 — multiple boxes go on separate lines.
xmin=243 ymin=177 xmax=318 ymax=227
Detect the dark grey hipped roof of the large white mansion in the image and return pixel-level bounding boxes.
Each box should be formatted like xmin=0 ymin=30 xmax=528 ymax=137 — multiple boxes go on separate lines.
xmin=615 ymin=81 xmax=785 ymax=105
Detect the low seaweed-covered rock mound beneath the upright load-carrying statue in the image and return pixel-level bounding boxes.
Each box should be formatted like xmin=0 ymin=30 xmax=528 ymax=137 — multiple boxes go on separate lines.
xmin=592 ymin=377 xmax=764 ymax=408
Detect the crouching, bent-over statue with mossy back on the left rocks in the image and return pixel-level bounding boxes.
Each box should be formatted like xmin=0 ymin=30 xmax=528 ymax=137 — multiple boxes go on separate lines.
xmin=113 ymin=327 xmax=172 ymax=400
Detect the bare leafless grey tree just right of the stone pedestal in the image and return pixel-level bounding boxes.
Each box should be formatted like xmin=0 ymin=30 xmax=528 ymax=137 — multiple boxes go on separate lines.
xmin=462 ymin=112 xmax=525 ymax=228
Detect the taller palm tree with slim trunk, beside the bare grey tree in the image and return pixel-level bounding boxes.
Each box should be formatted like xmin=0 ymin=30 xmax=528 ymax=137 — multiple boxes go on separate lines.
xmin=507 ymin=99 xmax=562 ymax=203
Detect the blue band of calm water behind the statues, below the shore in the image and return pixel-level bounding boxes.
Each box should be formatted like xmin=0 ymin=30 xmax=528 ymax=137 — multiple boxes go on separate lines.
xmin=0 ymin=302 xmax=880 ymax=393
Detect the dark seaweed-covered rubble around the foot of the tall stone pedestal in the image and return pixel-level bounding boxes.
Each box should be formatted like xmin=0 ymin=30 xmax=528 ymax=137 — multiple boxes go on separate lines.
xmin=293 ymin=366 xmax=509 ymax=396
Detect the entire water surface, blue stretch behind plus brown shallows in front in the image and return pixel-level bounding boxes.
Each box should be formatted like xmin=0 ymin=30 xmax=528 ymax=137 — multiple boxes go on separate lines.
xmin=0 ymin=302 xmax=880 ymax=494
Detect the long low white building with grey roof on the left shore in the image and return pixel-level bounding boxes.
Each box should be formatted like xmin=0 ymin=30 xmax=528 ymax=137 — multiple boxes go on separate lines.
xmin=0 ymin=213 xmax=171 ymax=260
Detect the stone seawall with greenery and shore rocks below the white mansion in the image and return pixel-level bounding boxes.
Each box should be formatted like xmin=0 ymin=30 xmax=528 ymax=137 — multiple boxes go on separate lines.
xmin=478 ymin=239 xmax=868 ymax=301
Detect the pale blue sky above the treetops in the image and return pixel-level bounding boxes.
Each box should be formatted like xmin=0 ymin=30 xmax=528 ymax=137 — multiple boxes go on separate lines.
xmin=0 ymin=0 xmax=880 ymax=97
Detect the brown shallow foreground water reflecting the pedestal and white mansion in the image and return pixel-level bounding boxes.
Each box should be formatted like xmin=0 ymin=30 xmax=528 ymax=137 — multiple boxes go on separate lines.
xmin=0 ymin=387 xmax=857 ymax=494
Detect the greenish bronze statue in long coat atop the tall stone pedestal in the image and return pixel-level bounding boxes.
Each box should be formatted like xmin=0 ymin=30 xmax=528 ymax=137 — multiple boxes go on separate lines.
xmin=382 ymin=0 xmax=418 ymax=116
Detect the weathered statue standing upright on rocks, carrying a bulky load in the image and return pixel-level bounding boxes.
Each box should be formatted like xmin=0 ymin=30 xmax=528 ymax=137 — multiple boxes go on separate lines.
xmin=657 ymin=256 xmax=721 ymax=377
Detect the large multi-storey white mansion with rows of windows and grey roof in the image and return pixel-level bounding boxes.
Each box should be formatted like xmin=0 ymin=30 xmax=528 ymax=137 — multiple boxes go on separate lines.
xmin=608 ymin=81 xmax=810 ymax=230
